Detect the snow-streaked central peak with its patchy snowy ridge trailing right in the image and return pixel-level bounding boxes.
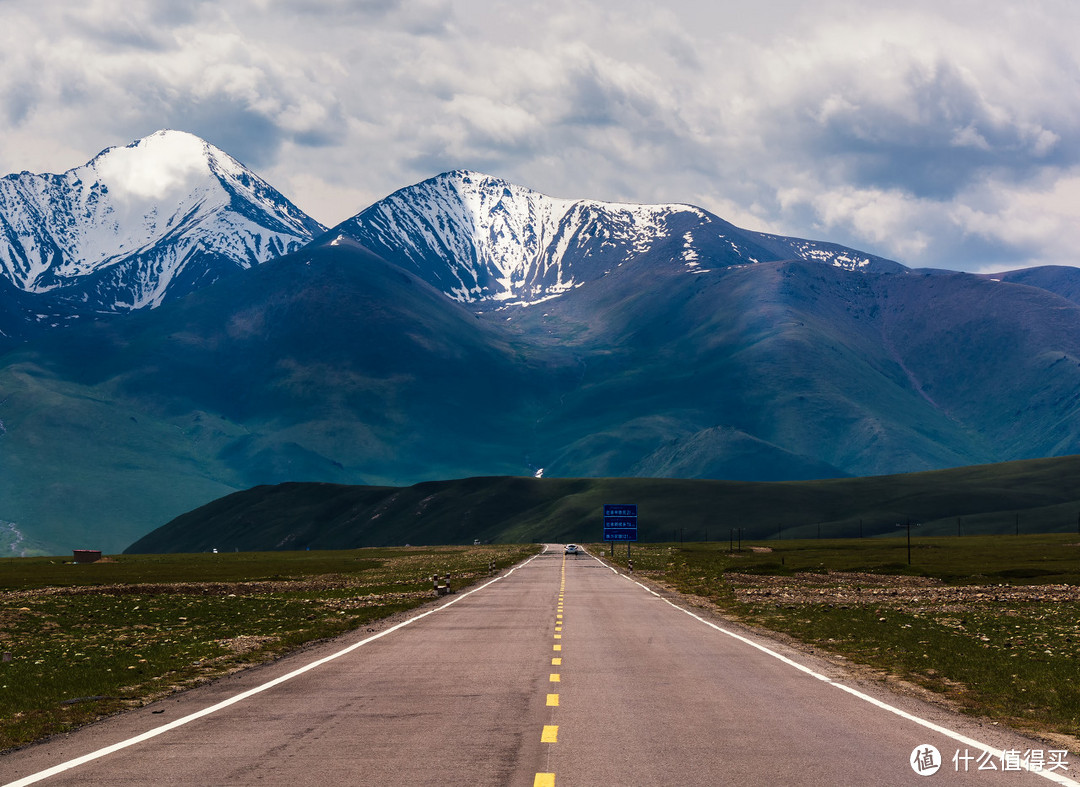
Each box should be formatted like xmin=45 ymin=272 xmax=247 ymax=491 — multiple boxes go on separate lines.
xmin=334 ymin=169 xmax=902 ymax=307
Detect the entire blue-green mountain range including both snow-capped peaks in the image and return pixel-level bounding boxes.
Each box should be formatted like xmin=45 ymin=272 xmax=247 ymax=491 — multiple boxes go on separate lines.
xmin=0 ymin=132 xmax=1080 ymax=554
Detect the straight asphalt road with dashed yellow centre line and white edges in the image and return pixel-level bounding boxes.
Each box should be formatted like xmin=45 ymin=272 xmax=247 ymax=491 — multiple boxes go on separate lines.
xmin=0 ymin=547 xmax=1080 ymax=787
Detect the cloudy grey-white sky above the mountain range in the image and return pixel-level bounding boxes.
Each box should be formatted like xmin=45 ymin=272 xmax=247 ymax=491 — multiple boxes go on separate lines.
xmin=0 ymin=0 xmax=1080 ymax=271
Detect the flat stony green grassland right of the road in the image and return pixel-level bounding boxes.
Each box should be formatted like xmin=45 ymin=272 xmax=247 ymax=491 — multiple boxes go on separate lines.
xmin=592 ymin=534 xmax=1080 ymax=751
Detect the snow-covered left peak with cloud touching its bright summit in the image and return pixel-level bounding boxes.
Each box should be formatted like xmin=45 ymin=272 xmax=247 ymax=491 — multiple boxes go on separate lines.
xmin=0 ymin=131 xmax=323 ymax=311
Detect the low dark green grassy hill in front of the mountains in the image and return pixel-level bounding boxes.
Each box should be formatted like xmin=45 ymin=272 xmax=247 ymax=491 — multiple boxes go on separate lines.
xmin=126 ymin=457 xmax=1080 ymax=553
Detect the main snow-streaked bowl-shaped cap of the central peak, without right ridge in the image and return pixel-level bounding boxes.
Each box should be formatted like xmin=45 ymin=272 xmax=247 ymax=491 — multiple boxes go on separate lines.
xmin=336 ymin=169 xmax=707 ymax=303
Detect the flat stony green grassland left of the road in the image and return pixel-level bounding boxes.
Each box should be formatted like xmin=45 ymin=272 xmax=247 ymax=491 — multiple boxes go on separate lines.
xmin=0 ymin=546 xmax=537 ymax=750
